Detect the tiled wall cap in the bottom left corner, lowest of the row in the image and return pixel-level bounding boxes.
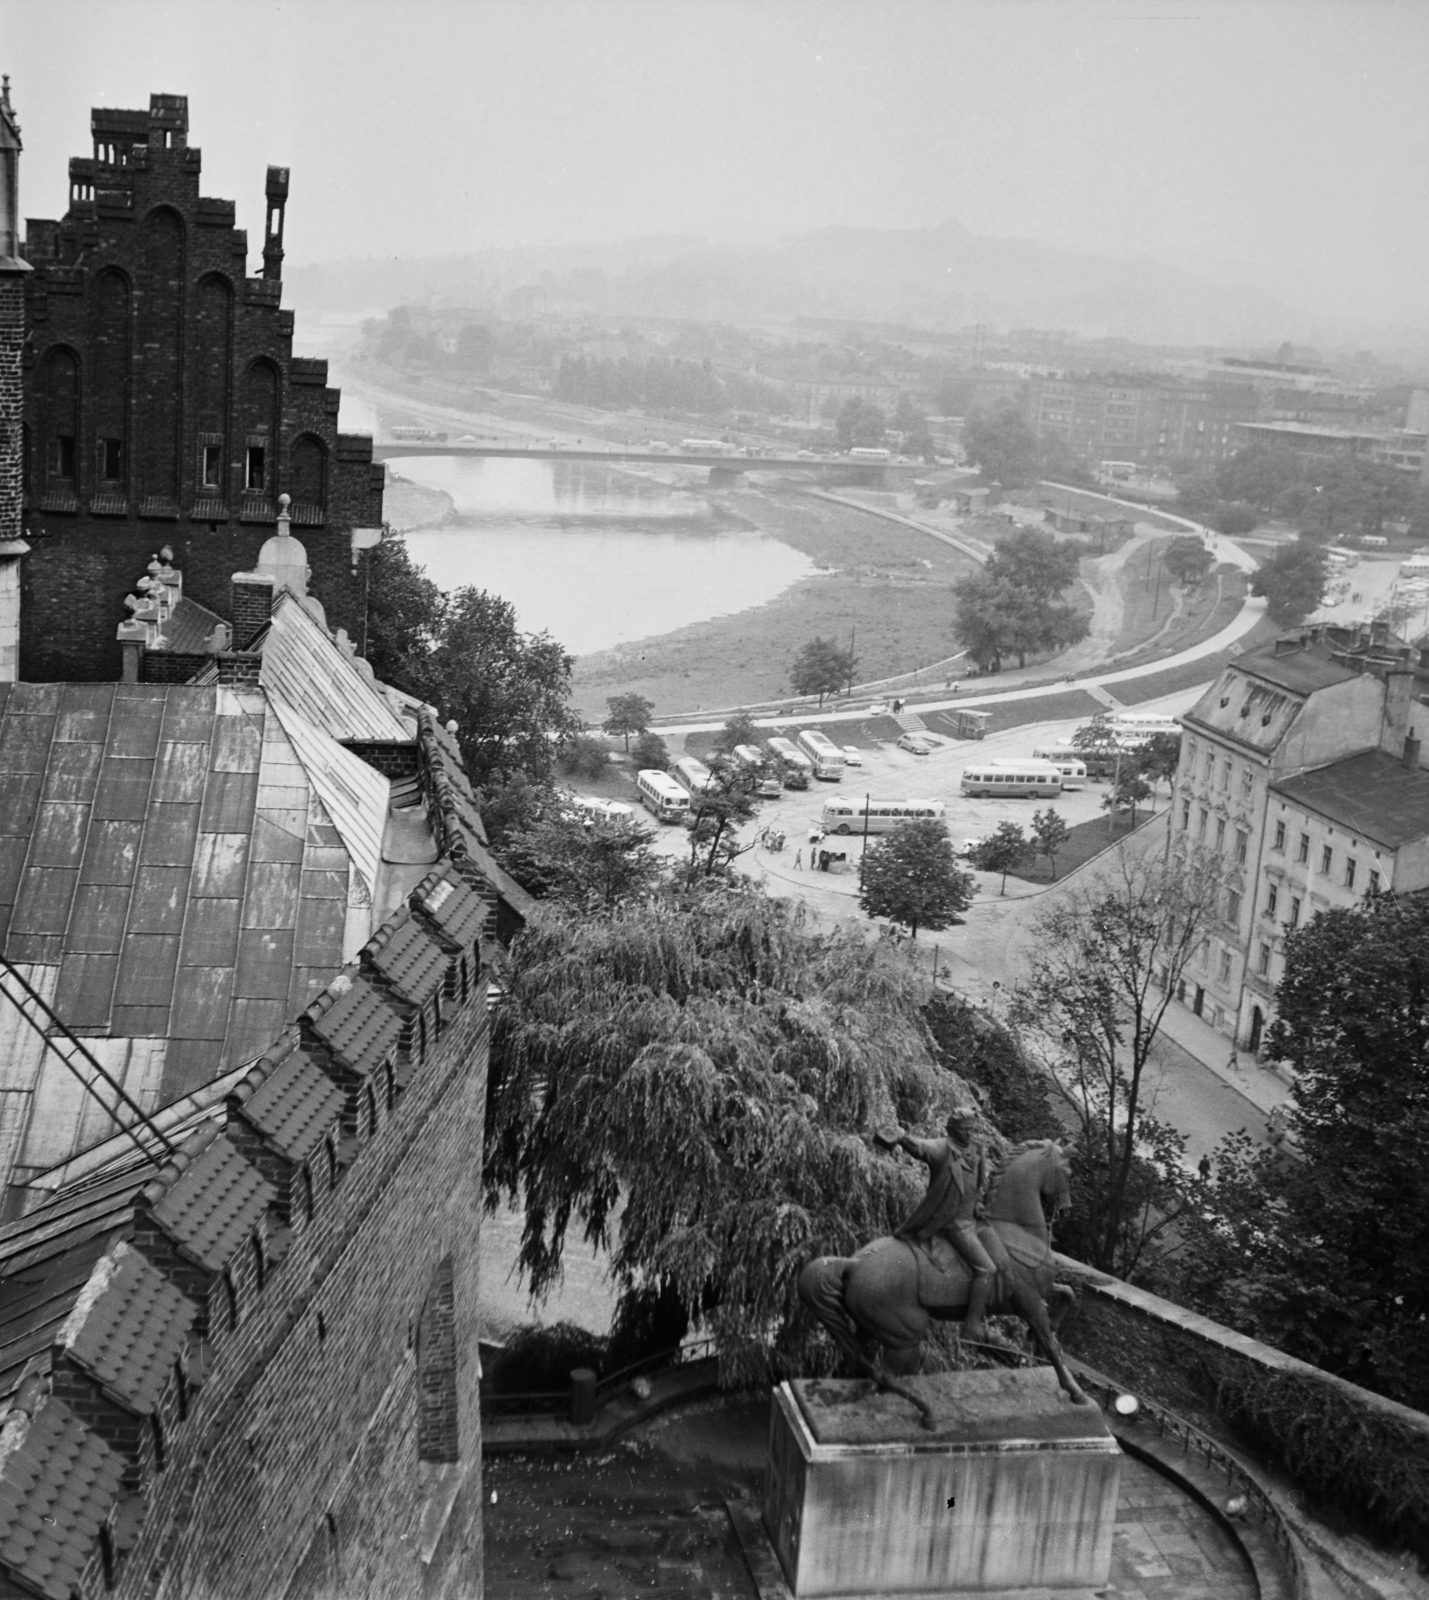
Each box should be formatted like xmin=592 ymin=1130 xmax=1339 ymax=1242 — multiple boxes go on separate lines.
xmin=0 ymin=1397 xmax=125 ymax=1600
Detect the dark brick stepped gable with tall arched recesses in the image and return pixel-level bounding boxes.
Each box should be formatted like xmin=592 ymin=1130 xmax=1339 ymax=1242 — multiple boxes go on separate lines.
xmin=21 ymin=96 xmax=382 ymax=680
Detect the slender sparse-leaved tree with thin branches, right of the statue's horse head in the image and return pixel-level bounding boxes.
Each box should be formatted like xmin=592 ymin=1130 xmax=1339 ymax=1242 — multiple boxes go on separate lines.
xmin=1011 ymin=845 xmax=1219 ymax=1278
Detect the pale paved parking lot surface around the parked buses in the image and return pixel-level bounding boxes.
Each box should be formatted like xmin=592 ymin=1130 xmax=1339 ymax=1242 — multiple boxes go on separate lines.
xmin=651 ymin=690 xmax=1200 ymax=915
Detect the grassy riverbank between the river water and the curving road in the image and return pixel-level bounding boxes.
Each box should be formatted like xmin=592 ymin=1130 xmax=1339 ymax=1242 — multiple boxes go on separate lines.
xmin=571 ymin=480 xmax=975 ymax=722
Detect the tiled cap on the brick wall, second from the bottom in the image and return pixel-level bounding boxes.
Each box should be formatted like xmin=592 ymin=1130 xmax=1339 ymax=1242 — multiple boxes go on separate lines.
xmin=58 ymin=1240 xmax=194 ymax=1416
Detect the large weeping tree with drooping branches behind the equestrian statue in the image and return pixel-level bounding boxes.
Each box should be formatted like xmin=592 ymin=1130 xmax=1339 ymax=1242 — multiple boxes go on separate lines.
xmin=485 ymin=883 xmax=968 ymax=1382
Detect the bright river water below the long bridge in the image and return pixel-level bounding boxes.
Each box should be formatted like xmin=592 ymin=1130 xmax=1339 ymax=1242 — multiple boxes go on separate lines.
xmin=397 ymin=456 xmax=815 ymax=656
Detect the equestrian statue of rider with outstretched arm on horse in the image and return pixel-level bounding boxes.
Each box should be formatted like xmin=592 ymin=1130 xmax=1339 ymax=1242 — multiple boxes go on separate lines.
xmin=799 ymin=1106 xmax=1087 ymax=1427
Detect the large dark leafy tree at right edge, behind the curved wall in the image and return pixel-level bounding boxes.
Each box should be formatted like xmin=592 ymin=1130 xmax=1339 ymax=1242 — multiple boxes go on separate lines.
xmin=1179 ymin=894 xmax=1429 ymax=1410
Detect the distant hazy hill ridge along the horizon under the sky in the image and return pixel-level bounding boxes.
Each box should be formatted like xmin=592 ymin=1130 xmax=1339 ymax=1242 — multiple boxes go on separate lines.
xmin=288 ymin=222 xmax=1306 ymax=346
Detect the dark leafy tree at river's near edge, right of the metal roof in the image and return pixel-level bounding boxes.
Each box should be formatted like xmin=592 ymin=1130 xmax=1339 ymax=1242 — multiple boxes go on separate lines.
xmin=427 ymin=589 xmax=581 ymax=787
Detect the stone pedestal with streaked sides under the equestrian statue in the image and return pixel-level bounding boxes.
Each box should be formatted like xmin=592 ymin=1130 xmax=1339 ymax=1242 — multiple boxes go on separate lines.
xmin=763 ymin=1368 xmax=1122 ymax=1600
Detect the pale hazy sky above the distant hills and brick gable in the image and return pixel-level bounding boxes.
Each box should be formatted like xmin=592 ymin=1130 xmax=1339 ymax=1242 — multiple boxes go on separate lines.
xmin=0 ymin=0 xmax=1429 ymax=325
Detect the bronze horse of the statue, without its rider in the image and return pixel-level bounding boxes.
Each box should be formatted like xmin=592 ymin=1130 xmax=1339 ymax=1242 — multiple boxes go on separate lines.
xmin=799 ymin=1139 xmax=1087 ymax=1426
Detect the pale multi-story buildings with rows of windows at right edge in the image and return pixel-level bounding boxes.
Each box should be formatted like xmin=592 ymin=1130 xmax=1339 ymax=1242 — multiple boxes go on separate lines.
xmin=1171 ymin=635 xmax=1429 ymax=1050
